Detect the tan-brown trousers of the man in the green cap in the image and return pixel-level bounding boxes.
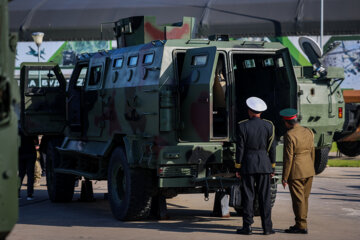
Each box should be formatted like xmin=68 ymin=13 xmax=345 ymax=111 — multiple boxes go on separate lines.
xmin=289 ymin=177 xmax=313 ymax=229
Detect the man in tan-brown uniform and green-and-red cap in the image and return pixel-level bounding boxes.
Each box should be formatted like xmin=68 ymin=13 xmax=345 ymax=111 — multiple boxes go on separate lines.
xmin=280 ymin=108 xmax=315 ymax=234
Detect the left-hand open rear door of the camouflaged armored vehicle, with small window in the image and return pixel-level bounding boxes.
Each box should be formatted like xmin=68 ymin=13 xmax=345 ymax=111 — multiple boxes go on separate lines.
xmin=179 ymin=47 xmax=218 ymax=142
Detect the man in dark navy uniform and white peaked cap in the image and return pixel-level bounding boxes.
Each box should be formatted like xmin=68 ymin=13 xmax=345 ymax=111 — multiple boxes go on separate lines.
xmin=235 ymin=97 xmax=276 ymax=235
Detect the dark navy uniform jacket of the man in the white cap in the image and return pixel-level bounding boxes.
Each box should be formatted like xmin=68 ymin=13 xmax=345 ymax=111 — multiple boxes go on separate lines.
xmin=235 ymin=117 xmax=276 ymax=174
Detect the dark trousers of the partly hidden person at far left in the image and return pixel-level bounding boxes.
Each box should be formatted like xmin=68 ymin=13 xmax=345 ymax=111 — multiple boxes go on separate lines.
xmin=19 ymin=153 xmax=36 ymax=197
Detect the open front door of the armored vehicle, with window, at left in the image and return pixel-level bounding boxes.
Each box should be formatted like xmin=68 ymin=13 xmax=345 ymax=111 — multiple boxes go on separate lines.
xmin=20 ymin=63 xmax=66 ymax=135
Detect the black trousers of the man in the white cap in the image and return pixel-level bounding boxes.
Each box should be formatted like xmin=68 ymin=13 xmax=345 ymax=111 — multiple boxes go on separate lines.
xmin=241 ymin=173 xmax=272 ymax=231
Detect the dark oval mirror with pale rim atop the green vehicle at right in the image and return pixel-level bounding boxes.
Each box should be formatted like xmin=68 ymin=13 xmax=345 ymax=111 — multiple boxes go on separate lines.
xmin=299 ymin=37 xmax=327 ymax=78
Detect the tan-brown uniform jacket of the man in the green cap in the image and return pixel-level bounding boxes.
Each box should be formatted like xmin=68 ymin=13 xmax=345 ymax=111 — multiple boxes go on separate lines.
xmin=283 ymin=125 xmax=315 ymax=181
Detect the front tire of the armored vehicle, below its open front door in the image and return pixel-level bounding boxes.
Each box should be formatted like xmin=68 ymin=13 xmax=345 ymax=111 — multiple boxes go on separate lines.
xmin=46 ymin=138 xmax=75 ymax=202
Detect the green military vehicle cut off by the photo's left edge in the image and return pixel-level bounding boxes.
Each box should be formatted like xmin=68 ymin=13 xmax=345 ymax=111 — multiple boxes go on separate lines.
xmin=0 ymin=0 xmax=20 ymax=239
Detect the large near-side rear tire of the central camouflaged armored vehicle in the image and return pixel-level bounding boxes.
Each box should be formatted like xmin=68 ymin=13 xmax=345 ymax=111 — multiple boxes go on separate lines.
xmin=108 ymin=148 xmax=155 ymax=221
